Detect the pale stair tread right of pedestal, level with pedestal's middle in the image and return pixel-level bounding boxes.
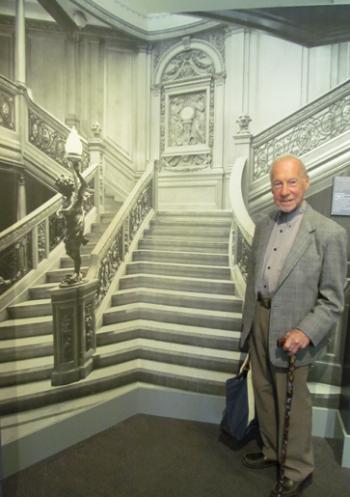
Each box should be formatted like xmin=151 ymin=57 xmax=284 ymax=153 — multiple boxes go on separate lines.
xmin=97 ymin=319 xmax=241 ymax=338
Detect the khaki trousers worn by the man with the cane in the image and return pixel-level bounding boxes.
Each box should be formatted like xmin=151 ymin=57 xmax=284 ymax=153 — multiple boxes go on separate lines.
xmin=250 ymin=303 xmax=314 ymax=481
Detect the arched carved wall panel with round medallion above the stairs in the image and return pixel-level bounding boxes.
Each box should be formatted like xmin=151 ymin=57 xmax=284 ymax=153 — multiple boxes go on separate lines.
xmin=160 ymin=49 xmax=215 ymax=172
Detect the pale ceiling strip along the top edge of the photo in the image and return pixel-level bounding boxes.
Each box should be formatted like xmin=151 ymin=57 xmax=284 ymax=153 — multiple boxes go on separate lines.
xmin=0 ymin=0 xmax=350 ymax=47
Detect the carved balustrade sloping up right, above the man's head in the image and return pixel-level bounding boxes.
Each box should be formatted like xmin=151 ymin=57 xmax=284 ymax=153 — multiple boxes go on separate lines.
xmin=250 ymin=81 xmax=350 ymax=182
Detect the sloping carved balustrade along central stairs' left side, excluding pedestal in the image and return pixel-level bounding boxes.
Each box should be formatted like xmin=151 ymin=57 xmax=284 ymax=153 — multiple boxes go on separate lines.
xmin=86 ymin=159 xmax=157 ymax=305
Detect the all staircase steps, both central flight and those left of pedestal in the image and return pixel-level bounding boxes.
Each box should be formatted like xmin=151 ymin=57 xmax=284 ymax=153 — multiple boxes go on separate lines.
xmin=0 ymin=212 xmax=242 ymax=415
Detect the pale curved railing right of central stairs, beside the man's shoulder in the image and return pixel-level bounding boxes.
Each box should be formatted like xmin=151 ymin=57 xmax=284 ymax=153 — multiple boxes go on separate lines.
xmin=229 ymin=157 xmax=255 ymax=294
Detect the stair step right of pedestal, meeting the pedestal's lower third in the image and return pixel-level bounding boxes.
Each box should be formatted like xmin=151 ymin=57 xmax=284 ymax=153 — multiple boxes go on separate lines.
xmin=94 ymin=338 xmax=241 ymax=373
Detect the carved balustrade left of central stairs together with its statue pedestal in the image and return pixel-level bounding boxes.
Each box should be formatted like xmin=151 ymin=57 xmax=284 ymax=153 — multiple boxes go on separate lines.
xmin=51 ymin=159 xmax=157 ymax=385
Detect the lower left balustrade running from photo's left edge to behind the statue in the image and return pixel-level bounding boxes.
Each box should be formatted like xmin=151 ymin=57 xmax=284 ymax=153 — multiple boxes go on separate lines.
xmin=0 ymin=165 xmax=98 ymax=294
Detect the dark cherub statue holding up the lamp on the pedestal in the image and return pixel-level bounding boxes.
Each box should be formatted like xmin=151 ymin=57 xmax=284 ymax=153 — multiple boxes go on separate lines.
xmin=55 ymin=161 xmax=88 ymax=286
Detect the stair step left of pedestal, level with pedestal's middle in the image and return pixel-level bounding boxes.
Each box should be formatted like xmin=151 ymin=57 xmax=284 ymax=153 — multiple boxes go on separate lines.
xmin=0 ymin=316 xmax=52 ymax=343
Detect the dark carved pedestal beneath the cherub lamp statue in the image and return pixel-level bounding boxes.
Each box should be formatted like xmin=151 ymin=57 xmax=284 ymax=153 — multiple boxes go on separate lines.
xmin=51 ymin=280 xmax=97 ymax=386
